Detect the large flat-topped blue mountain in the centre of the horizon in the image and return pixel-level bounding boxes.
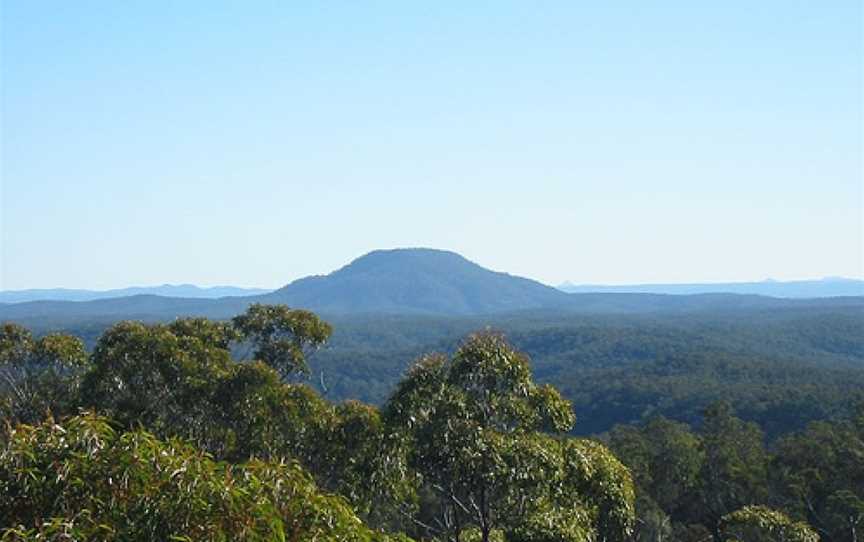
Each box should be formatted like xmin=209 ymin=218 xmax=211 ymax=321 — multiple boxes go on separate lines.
xmin=263 ymin=248 xmax=571 ymax=315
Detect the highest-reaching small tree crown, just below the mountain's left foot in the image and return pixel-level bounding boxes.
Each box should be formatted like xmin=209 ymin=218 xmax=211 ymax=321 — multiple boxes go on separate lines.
xmin=233 ymin=303 xmax=333 ymax=378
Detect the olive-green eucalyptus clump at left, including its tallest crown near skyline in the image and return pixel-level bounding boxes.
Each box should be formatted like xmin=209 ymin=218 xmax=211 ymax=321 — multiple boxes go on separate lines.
xmin=83 ymin=304 xmax=330 ymax=442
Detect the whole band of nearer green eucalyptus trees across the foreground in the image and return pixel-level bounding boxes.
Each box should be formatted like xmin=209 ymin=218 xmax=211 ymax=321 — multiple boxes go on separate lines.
xmin=0 ymin=305 xmax=864 ymax=542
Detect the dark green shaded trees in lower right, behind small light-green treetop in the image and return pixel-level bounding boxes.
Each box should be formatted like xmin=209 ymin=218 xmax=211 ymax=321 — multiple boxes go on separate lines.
xmin=609 ymin=403 xmax=864 ymax=542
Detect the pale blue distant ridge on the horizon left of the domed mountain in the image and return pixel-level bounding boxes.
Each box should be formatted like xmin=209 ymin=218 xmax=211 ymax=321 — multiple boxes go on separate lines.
xmin=0 ymin=284 xmax=272 ymax=303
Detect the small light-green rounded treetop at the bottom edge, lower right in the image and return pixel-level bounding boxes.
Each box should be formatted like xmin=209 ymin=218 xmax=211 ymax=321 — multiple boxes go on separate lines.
xmin=719 ymin=506 xmax=819 ymax=542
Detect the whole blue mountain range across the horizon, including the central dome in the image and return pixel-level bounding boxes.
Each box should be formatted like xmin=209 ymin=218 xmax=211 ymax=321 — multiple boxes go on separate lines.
xmin=0 ymin=249 xmax=864 ymax=325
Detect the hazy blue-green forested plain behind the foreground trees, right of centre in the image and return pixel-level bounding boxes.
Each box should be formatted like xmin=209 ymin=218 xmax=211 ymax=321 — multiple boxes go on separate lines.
xmin=302 ymin=307 xmax=864 ymax=435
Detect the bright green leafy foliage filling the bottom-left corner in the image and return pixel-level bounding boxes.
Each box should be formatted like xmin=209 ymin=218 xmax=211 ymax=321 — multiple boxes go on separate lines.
xmin=0 ymin=414 xmax=404 ymax=542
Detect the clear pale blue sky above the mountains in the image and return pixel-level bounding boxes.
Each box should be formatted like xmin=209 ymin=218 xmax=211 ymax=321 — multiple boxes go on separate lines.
xmin=0 ymin=0 xmax=864 ymax=290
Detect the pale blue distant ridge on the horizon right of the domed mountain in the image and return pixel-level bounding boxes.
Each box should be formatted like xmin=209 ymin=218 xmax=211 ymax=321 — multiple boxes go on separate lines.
xmin=558 ymin=277 xmax=864 ymax=298
